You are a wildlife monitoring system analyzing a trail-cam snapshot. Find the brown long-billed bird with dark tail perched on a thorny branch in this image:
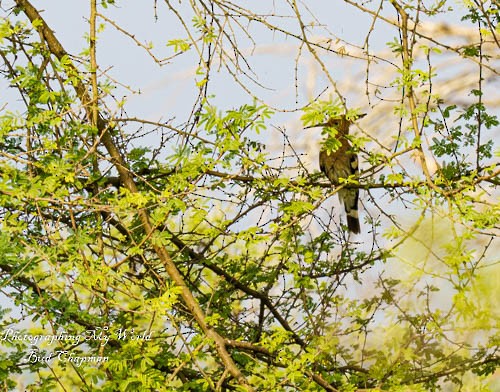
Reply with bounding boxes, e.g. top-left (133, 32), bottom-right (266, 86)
top-left (307, 114), bottom-right (364, 234)
